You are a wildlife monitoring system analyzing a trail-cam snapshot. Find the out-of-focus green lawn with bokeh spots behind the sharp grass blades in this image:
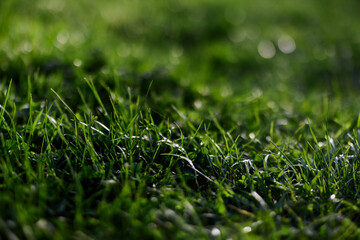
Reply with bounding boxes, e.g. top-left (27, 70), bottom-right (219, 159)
top-left (0, 0), bottom-right (360, 127)
